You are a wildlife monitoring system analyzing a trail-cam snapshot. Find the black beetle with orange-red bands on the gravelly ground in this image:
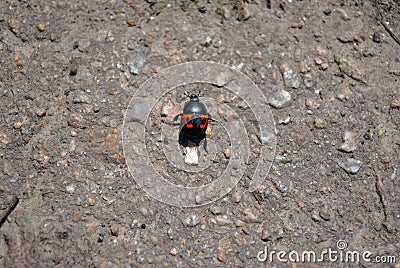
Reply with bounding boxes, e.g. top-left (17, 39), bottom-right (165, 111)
top-left (174, 94), bottom-right (211, 151)
